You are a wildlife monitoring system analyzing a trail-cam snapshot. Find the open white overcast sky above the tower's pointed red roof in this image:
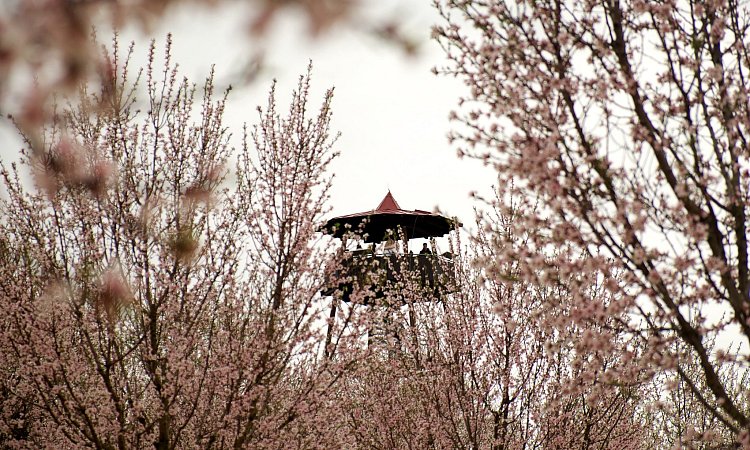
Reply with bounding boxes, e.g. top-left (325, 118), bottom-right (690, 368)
top-left (0, 0), bottom-right (502, 237)
